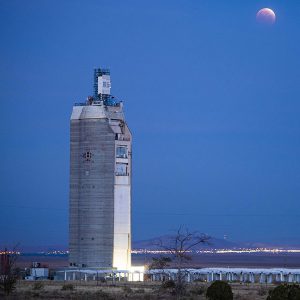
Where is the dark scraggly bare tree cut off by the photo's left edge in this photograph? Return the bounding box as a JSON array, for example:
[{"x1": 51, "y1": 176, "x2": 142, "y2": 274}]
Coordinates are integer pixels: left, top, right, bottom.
[{"x1": 0, "y1": 246, "x2": 18, "y2": 295}]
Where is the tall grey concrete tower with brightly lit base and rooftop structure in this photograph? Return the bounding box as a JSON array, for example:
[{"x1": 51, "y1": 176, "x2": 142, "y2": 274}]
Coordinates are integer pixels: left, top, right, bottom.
[{"x1": 69, "y1": 69, "x2": 132, "y2": 270}]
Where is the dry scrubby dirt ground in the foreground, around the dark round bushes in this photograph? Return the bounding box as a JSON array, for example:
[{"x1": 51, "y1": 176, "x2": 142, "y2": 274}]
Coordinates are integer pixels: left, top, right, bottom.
[{"x1": 0, "y1": 281, "x2": 275, "y2": 300}]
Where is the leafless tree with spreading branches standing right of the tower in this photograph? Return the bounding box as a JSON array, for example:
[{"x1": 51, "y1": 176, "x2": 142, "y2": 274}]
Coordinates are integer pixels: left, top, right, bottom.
[{"x1": 157, "y1": 225, "x2": 210, "y2": 295}]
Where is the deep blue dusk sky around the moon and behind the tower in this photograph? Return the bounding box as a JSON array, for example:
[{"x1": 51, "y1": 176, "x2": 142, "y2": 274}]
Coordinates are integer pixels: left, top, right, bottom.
[{"x1": 0, "y1": 0, "x2": 300, "y2": 247}]
